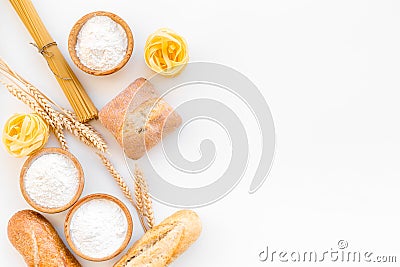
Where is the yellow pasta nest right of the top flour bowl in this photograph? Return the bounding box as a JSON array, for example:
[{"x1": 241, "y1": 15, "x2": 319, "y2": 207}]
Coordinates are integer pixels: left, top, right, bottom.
[{"x1": 144, "y1": 28, "x2": 189, "y2": 76}]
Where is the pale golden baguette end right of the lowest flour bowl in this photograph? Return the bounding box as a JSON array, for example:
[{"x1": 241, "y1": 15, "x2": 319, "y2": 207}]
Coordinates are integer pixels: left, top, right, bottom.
[{"x1": 114, "y1": 210, "x2": 201, "y2": 267}]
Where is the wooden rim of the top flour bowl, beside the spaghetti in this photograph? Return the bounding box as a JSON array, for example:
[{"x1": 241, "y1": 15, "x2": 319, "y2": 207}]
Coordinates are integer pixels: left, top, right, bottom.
[{"x1": 68, "y1": 11, "x2": 134, "y2": 76}]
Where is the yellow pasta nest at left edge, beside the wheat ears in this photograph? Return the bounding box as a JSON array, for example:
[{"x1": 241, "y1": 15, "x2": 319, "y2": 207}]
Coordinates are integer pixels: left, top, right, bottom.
[{"x1": 3, "y1": 114, "x2": 49, "y2": 158}]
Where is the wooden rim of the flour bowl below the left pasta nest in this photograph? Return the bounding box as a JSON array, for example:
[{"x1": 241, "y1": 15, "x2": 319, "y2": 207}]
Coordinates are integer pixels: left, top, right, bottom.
[{"x1": 19, "y1": 147, "x2": 85, "y2": 213}]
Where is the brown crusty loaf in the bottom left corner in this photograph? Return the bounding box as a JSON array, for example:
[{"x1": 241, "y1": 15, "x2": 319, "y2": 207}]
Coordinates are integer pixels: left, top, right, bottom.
[{"x1": 8, "y1": 210, "x2": 81, "y2": 267}]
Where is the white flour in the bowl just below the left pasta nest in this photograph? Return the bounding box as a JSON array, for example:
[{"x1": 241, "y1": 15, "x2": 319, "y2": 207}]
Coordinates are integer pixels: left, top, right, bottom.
[{"x1": 24, "y1": 153, "x2": 79, "y2": 208}]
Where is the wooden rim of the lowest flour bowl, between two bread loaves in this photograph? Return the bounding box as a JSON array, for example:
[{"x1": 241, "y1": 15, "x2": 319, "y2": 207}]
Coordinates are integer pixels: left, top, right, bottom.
[{"x1": 64, "y1": 194, "x2": 133, "y2": 262}]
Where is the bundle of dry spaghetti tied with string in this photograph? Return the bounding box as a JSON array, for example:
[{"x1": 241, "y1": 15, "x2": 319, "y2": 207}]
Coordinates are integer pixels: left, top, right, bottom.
[{"x1": 10, "y1": 0, "x2": 97, "y2": 122}]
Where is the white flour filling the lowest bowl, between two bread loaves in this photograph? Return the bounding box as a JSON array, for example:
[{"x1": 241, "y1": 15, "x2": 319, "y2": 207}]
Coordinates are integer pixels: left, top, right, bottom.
[{"x1": 69, "y1": 199, "x2": 128, "y2": 259}]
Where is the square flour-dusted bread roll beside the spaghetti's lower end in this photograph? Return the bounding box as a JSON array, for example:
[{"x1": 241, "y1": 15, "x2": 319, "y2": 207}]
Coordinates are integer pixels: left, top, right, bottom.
[{"x1": 99, "y1": 78, "x2": 182, "y2": 159}]
